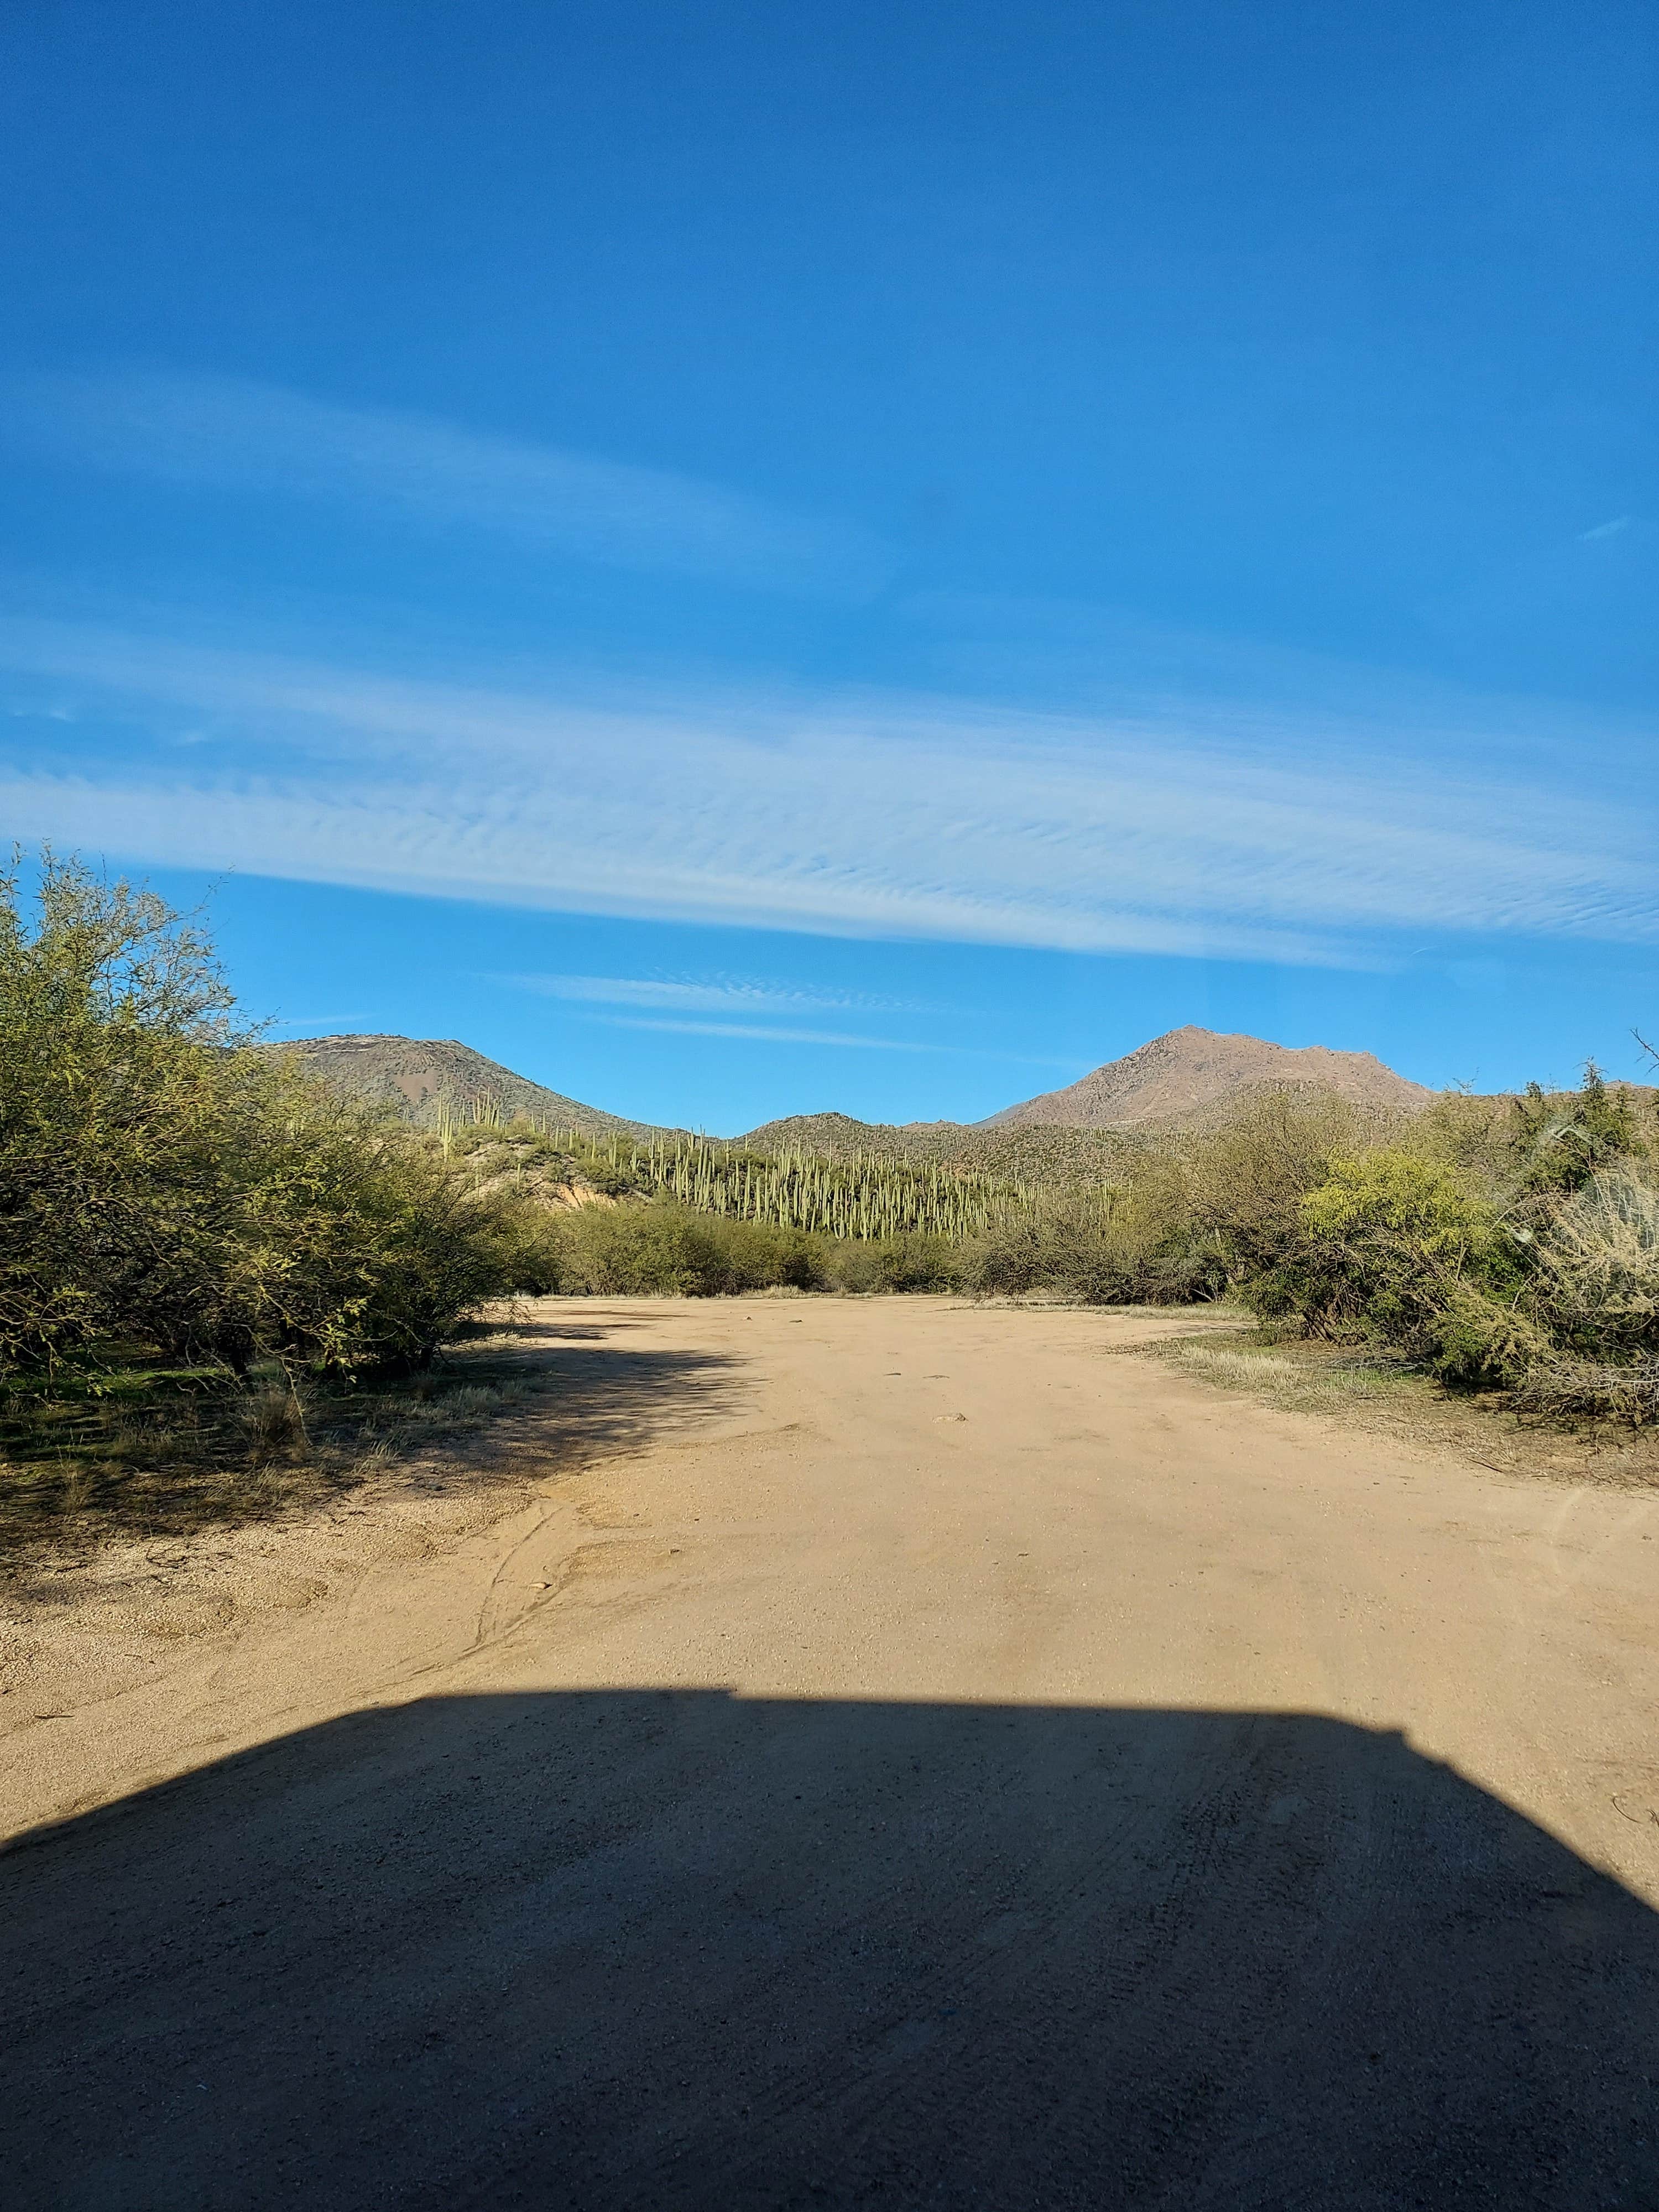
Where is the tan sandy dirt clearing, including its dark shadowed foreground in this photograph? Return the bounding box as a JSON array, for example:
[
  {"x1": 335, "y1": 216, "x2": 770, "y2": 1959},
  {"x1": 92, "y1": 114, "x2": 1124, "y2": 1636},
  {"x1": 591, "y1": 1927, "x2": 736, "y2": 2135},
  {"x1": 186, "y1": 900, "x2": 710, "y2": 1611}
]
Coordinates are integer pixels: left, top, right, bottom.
[{"x1": 0, "y1": 1298, "x2": 1659, "y2": 2212}]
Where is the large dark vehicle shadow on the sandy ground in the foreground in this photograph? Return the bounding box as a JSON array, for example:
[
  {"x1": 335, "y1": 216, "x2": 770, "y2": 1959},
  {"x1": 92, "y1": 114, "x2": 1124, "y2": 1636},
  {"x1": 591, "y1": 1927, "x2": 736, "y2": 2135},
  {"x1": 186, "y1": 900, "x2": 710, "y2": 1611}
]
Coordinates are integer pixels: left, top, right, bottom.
[{"x1": 0, "y1": 1690, "x2": 1659, "y2": 2212}]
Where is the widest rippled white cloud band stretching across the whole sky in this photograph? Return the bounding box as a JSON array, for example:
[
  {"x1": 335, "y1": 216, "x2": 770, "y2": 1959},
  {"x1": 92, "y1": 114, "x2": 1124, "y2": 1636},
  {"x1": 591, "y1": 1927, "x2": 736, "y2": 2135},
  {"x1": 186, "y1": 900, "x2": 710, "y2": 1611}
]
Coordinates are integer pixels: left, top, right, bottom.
[{"x1": 0, "y1": 622, "x2": 1659, "y2": 967}]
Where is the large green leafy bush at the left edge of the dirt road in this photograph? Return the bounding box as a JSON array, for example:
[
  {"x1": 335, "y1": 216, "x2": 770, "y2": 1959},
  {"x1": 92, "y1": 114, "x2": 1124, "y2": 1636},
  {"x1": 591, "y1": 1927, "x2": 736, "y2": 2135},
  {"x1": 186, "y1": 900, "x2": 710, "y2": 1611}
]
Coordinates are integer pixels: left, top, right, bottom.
[{"x1": 0, "y1": 854, "x2": 535, "y2": 1376}]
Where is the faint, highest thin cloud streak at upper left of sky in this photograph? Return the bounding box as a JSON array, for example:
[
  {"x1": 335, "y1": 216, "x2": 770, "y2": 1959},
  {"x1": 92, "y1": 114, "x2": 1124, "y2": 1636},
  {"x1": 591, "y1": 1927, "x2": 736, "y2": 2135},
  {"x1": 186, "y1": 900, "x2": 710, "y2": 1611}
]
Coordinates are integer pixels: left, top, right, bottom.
[{"x1": 4, "y1": 374, "x2": 891, "y2": 599}]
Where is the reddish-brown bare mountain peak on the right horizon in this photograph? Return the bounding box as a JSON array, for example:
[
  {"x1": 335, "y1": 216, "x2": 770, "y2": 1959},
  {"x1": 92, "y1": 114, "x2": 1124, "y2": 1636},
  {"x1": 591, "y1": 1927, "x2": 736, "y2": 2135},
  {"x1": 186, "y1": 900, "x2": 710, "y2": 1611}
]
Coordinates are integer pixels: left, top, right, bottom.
[{"x1": 978, "y1": 1024, "x2": 1431, "y2": 1130}]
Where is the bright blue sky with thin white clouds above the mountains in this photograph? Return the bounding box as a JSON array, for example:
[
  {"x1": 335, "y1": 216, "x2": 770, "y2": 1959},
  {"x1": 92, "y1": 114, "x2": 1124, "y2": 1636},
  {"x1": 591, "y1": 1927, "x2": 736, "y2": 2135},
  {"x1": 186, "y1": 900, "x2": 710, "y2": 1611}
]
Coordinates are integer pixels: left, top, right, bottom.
[{"x1": 0, "y1": 0, "x2": 1659, "y2": 1130}]
